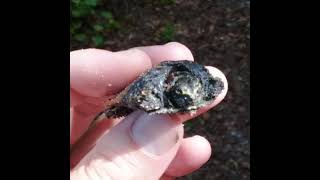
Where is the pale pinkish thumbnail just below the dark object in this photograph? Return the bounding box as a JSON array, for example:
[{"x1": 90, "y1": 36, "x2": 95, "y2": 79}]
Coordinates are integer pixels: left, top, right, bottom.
[{"x1": 131, "y1": 113, "x2": 181, "y2": 155}]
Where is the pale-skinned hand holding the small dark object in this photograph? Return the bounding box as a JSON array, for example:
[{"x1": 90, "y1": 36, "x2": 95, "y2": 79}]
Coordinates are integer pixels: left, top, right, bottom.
[{"x1": 70, "y1": 42, "x2": 228, "y2": 180}]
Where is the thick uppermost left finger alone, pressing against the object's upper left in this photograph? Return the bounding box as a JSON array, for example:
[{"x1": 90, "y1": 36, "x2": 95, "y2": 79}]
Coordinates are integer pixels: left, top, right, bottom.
[{"x1": 70, "y1": 49, "x2": 151, "y2": 103}]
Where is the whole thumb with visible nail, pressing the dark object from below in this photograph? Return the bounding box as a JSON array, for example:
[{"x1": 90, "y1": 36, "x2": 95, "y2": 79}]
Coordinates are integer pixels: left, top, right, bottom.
[{"x1": 70, "y1": 112, "x2": 183, "y2": 180}]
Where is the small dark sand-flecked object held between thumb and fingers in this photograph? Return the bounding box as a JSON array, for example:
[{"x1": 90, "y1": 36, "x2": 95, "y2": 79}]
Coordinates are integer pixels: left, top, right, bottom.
[{"x1": 93, "y1": 60, "x2": 224, "y2": 124}]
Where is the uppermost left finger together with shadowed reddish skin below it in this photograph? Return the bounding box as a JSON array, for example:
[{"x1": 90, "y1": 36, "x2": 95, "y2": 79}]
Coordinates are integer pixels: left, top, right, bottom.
[{"x1": 70, "y1": 49, "x2": 152, "y2": 144}]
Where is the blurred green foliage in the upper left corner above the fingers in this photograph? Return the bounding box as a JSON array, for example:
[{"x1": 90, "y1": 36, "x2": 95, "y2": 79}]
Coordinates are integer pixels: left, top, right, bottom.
[{"x1": 70, "y1": 0, "x2": 120, "y2": 47}]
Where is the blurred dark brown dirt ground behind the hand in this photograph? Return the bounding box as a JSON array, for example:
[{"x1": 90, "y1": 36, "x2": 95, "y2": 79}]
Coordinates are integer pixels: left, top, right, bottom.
[{"x1": 70, "y1": 0, "x2": 250, "y2": 180}]
